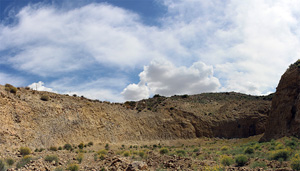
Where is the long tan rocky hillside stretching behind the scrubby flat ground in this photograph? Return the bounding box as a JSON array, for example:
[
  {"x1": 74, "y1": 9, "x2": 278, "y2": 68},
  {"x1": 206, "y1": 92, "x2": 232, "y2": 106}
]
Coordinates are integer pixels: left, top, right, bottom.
[{"x1": 0, "y1": 85, "x2": 272, "y2": 148}]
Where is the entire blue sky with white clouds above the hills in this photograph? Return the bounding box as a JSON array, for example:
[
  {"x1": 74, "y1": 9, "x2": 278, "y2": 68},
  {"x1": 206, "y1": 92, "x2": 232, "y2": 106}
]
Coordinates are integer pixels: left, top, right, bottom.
[{"x1": 0, "y1": 0, "x2": 300, "y2": 102}]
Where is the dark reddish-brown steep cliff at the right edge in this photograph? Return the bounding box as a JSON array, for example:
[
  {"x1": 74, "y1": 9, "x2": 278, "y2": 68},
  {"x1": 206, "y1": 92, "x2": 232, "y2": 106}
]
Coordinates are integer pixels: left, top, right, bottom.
[{"x1": 261, "y1": 61, "x2": 300, "y2": 141}]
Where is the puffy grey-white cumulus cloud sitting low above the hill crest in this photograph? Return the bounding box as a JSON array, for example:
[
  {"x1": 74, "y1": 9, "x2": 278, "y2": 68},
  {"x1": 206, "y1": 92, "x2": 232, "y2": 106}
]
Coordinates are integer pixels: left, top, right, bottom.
[{"x1": 122, "y1": 60, "x2": 220, "y2": 100}]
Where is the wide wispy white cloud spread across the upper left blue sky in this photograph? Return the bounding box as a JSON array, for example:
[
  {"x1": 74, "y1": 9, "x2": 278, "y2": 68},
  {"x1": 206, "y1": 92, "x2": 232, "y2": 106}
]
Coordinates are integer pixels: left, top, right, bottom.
[{"x1": 0, "y1": 4, "x2": 186, "y2": 76}]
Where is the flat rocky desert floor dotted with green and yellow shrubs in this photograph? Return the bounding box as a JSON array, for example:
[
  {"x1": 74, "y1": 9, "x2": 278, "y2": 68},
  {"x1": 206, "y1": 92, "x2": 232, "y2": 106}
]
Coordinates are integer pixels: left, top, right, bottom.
[{"x1": 0, "y1": 136, "x2": 300, "y2": 171}]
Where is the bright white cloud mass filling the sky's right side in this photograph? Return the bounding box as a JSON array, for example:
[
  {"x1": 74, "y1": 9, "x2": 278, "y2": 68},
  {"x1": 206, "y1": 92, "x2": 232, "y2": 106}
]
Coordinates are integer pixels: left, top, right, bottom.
[{"x1": 165, "y1": 0, "x2": 300, "y2": 94}]
